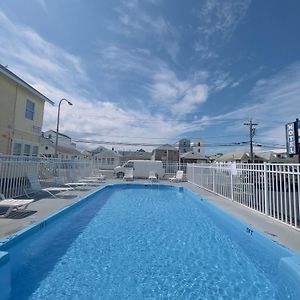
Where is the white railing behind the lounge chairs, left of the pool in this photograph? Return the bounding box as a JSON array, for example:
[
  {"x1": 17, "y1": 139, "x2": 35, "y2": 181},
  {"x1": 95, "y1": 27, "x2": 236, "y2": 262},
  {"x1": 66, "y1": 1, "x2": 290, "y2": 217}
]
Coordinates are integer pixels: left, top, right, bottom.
[{"x1": 0, "y1": 155, "x2": 97, "y2": 198}]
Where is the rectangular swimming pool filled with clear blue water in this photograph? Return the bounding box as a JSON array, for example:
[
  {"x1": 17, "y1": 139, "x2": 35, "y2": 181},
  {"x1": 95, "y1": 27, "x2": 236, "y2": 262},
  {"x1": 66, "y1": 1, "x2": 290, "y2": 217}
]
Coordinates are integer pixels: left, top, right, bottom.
[{"x1": 0, "y1": 184, "x2": 300, "y2": 300}]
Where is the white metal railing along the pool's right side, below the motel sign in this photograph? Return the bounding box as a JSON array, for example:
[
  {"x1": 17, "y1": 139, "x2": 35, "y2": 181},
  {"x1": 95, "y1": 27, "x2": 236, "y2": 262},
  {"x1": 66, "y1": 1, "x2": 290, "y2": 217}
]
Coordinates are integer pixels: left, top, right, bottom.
[{"x1": 187, "y1": 163, "x2": 300, "y2": 228}]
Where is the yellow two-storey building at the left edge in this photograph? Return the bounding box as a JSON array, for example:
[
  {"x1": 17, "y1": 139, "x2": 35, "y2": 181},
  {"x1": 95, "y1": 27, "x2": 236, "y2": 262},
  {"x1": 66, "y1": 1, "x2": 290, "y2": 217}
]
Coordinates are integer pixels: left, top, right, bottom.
[{"x1": 0, "y1": 64, "x2": 54, "y2": 156}]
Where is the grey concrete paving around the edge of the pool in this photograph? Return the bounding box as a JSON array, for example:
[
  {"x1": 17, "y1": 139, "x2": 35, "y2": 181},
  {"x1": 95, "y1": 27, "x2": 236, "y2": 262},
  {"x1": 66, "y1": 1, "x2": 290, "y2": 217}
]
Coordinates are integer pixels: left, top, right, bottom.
[{"x1": 0, "y1": 179, "x2": 300, "y2": 254}]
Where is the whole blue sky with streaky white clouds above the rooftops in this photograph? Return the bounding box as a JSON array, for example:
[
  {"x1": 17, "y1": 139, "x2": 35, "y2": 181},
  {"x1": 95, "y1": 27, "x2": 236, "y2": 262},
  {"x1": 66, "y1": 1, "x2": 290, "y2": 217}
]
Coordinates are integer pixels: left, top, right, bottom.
[{"x1": 0, "y1": 0, "x2": 300, "y2": 153}]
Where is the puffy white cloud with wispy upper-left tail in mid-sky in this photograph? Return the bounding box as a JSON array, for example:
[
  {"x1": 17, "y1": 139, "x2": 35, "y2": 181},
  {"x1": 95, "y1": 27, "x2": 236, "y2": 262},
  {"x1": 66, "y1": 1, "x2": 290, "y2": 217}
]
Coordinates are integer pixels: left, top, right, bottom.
[{"x1": 99, "y1": 45, "x2": 209, "y2": 116}]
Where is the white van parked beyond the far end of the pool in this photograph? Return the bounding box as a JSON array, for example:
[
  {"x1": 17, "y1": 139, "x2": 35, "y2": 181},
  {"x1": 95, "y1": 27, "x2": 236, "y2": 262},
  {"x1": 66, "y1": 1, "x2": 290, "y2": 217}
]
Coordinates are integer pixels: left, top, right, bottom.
[{"x1": 115, "y1": 160, "x2": 165, "y2": 178}]
